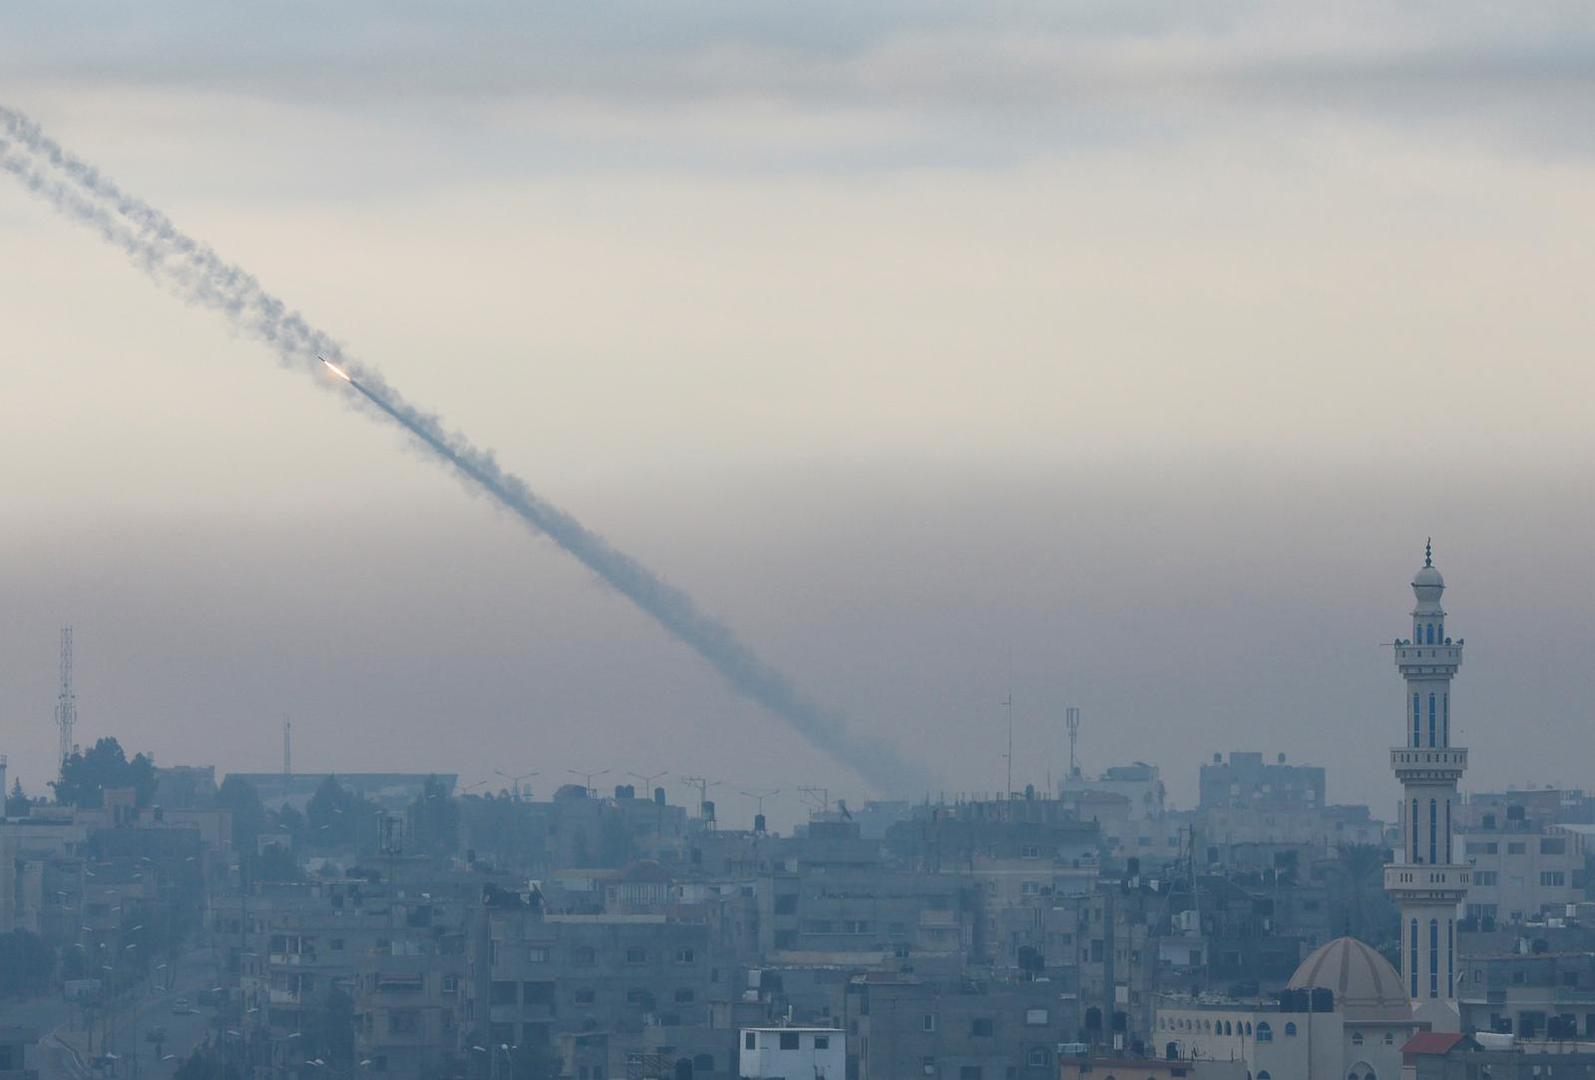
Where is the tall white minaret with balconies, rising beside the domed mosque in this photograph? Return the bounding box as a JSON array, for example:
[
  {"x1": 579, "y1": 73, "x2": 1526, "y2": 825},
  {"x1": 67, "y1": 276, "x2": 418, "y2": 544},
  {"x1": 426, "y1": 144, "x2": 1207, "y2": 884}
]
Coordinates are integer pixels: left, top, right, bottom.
[{"x1": 1384, "y1": 544, "x2": 1472, "y2": 1031}]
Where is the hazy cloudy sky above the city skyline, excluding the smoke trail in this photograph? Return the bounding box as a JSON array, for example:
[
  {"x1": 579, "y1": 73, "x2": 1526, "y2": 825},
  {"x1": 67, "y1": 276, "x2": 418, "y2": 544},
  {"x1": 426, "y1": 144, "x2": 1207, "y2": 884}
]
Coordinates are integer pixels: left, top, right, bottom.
[{"x1": 0, "y1": 0, "x2": 1595, "y2": 823}]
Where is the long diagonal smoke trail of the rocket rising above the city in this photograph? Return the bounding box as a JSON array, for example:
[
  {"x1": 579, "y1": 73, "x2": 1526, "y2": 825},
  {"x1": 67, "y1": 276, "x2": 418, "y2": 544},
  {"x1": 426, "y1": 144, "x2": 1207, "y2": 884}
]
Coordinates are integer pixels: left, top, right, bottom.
[{"x1": 0, "y1": 105, "x2": 928, "y2": 794}]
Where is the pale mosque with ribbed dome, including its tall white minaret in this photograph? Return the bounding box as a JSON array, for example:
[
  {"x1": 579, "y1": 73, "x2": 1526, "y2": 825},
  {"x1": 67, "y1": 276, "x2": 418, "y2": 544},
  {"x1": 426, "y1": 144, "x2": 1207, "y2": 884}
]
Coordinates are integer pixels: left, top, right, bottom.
[{"x1": 1155, "y1": 546, "x2": 1469, "y2": 1080}]
